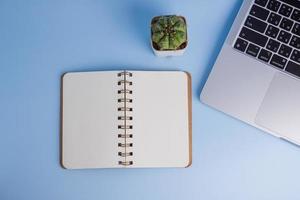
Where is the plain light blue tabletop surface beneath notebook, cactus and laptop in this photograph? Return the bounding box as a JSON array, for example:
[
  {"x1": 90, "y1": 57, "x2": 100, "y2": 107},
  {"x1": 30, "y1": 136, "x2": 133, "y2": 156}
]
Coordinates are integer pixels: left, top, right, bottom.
[{"x1": 0, "y1": 0, "x2": 300, "y2": 200}]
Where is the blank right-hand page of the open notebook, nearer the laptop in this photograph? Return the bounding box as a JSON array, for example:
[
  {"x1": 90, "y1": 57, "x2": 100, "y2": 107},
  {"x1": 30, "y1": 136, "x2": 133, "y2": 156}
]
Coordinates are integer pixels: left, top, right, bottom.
[{"x1": 127, "y1": 71, "x2": 191, "y2": 168}]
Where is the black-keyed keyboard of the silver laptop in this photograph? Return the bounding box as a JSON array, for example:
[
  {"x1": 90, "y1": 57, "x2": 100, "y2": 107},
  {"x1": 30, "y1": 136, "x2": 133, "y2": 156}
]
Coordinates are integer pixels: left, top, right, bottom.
[{"x1": 234, "y1": 0, "x2": 300, "y2": 78}]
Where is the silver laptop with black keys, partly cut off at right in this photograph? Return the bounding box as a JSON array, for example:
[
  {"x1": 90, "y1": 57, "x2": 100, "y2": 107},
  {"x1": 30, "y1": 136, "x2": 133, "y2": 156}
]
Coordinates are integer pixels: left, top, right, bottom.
[{"x1": 200, "y1": 0, "x2": 300, "y2": 145}]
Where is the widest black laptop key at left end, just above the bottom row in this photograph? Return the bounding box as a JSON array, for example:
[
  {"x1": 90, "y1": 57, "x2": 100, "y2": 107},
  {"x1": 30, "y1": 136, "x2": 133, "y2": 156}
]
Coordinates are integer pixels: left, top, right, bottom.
[{"x1": 240, "y1": 27, "x2": 268, "y2": 47}]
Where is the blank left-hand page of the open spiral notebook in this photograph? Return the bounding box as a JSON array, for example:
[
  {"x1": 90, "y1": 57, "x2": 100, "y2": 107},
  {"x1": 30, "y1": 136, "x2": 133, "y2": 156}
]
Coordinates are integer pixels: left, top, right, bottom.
[{"x1": 62, "y1": 71, "x2": 120, "y2": 169}]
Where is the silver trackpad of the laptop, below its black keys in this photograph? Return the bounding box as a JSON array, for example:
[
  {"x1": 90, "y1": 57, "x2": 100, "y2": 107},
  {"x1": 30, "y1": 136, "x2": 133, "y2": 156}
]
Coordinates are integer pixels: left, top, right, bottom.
[{"x1": 255, "y1": 72, "x2": 300, "y2": 144}]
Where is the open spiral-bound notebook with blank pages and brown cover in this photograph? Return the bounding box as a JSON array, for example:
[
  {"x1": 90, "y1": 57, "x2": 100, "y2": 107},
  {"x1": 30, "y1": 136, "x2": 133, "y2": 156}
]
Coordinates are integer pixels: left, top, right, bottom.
[{"x1": 62, "y1": 71, "x2": 192, "y2": 169}]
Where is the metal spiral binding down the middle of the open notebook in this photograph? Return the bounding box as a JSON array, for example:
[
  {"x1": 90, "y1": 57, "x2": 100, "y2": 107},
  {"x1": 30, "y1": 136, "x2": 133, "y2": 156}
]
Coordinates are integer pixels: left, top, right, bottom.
[{"x1": 118, "y1": 71, "x2": 133, "y2": 166}]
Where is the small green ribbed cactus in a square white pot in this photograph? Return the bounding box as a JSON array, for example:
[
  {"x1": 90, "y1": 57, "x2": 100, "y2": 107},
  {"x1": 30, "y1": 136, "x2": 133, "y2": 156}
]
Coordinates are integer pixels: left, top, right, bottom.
[{"x1": 151, "y1": 15, "x2": 188, "y2": 56}]
